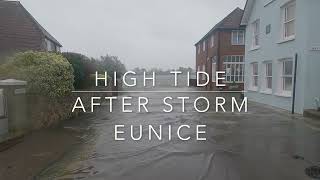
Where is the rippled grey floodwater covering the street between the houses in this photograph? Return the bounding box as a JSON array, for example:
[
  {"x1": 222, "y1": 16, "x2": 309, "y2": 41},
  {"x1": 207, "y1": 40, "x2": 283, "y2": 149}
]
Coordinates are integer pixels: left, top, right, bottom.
[{"x1": 38, "y1": 75, "x2": 320, "y2": 180}]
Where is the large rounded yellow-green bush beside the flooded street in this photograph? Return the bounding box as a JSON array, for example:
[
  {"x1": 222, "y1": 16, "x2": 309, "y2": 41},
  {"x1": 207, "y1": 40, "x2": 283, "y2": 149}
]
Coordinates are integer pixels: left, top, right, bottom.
[{"x1": 0, "y1": 51, "x2": 74, "y2": 98}]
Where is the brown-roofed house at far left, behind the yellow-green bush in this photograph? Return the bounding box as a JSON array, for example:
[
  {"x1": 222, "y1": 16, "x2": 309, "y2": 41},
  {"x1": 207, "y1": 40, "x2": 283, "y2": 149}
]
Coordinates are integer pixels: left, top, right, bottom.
[{"x1": 0, "y1": 1, "x2": 62, "y2": 59}]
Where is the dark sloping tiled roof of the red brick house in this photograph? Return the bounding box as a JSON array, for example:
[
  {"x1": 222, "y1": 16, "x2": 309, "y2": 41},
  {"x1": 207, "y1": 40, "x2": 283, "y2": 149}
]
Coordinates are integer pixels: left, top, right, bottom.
[{"x1": 195, "y1": 7, "x2": 243, "y2": 45}]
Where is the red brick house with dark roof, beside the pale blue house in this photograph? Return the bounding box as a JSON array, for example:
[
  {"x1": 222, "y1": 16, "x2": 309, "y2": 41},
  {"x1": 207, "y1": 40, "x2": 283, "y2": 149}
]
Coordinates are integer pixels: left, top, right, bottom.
[{"x1": 195, "y1": 8, "x2": 245, "y2": 90}]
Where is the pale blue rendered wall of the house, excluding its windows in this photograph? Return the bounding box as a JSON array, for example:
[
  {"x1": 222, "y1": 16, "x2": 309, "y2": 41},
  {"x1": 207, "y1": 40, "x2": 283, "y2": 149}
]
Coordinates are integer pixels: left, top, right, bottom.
[{"x1": 245, "y1": 0, "x2": 320, "y2": 113}]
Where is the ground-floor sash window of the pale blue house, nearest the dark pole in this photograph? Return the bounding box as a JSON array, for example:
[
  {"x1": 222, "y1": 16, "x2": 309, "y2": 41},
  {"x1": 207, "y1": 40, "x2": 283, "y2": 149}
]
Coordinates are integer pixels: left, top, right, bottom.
[{"x1": 281, "y1": 58, "x2": 293, "y2": 92}]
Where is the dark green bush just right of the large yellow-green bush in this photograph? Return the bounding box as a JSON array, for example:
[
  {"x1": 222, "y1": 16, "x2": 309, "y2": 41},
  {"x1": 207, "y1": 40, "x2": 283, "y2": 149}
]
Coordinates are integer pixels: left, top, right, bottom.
[{"x1": 62, "y1": 52, "x2": 97, "y2": 89}]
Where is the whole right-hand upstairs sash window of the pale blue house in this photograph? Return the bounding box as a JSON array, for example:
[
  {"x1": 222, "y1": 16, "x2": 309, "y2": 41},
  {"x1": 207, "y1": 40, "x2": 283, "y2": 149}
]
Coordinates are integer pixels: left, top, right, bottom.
[{"x1": 281, "y1": 1, "x2": 296, "y2": 39}]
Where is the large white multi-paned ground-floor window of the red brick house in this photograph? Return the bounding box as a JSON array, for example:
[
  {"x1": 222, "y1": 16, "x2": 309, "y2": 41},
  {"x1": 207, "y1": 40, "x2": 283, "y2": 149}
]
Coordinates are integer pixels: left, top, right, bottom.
[{"x1": 223, "y1": 56, "x2": 244, "y2": 83}]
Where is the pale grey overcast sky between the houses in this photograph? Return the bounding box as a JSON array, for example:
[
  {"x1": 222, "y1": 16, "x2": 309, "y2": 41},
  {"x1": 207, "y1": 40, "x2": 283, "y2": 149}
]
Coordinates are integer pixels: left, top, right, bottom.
[{"x1": 21, "y1": 0, "x2": 245, "y2": 69}]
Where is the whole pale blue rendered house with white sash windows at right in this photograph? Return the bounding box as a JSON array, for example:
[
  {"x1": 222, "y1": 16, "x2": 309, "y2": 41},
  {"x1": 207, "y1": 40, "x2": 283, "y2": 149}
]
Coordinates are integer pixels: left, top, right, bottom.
[{"x1": 241, "y1": 0, "x2": 320, "y2": 114}]
